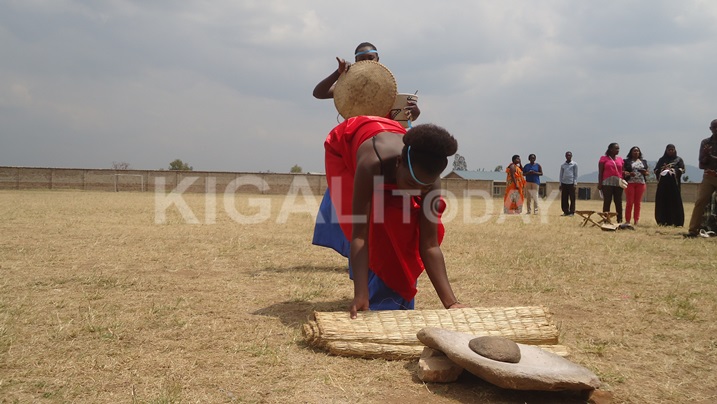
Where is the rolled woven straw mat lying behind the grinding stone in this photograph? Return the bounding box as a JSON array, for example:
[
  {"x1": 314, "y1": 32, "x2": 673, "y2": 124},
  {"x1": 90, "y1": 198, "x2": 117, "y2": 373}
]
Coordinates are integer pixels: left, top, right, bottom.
[{"x1": 303, "y1": 306, "x2": 568, "y2": 359}]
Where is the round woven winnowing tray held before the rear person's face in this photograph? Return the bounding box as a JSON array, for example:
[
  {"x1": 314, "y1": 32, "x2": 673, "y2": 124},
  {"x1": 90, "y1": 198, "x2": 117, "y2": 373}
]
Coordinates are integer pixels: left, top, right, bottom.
[{"x1": 334, "y1": 60, "x2": 398, "y2": 119}]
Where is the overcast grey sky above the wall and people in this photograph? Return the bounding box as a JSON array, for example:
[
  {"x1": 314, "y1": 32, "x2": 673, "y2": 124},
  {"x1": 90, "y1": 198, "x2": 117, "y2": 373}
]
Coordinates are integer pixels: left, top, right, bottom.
[{"x1": 0, "y1": 0, "x2": 717, "y2": 178}]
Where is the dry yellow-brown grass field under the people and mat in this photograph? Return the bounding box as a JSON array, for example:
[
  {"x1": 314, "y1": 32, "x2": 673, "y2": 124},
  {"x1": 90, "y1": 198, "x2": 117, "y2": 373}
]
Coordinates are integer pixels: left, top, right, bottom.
[{"x1": 0, "y1": 191, "x2": 717, "y2": 403}]
